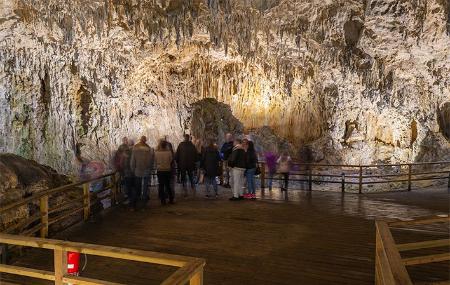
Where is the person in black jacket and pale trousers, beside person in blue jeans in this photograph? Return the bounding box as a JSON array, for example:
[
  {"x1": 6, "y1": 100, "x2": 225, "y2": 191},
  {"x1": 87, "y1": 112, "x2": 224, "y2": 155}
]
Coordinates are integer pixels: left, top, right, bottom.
[{"x1": 228, "y1": 139, "x2": 246, "y2": 201}]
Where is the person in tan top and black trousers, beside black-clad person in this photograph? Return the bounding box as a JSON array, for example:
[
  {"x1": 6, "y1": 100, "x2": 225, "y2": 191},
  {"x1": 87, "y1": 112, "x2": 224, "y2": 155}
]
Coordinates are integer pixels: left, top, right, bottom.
[{"x1": 155, "y1": 140, "x2": 175, "y2": 205}]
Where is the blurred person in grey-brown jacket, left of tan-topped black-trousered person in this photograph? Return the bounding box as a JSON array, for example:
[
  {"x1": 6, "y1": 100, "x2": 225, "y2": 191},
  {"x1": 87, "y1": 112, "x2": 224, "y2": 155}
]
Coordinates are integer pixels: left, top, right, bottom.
[{"x1": 130, "y1": 136, "x2": 155, "y2": 210}]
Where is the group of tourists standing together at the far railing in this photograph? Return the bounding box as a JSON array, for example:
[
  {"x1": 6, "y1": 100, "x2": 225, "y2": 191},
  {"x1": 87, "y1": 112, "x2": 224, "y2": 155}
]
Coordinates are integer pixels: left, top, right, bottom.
[{"x1": 114, "y1": 134, "x2": 291, "y2": 210}]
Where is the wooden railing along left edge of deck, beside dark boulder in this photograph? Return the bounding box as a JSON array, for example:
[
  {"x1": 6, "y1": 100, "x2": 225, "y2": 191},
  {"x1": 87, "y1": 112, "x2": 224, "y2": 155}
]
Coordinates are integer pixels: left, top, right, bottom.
[{"x1": 0, "y1": 173, "x2": 118, "y2": 238}]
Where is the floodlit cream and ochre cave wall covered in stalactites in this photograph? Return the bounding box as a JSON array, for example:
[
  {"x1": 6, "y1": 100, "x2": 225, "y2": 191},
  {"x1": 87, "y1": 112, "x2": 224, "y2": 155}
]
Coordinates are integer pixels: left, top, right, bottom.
[{"x1": 0, "y1": 0, "x2": 450, "y2": 172}]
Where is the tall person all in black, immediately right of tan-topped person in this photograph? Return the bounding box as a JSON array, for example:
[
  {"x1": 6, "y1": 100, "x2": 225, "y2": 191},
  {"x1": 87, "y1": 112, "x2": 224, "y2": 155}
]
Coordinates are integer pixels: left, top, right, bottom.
[{"x1": 175, "y1": 134, "x2": 198, "y2": 197}]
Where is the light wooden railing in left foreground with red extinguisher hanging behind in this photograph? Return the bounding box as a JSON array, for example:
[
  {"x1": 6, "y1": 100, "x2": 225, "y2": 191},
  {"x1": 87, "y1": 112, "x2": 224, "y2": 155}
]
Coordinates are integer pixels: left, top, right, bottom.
[{"x1": 0, "y1": 234, "x2": 205, "y2": 285}]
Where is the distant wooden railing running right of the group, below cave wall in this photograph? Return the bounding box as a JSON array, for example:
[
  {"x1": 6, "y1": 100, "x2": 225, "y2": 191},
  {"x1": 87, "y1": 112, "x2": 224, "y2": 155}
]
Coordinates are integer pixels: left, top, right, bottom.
[{"x1": 260, "y1": 161, "x2": 450, "y2": 194}]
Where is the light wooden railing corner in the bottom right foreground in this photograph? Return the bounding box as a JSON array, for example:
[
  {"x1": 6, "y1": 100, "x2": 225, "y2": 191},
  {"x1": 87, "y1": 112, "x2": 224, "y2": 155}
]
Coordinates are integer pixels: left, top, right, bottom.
[{"x1": 375, "y1": 216, "x2": 450, "y2": 285}]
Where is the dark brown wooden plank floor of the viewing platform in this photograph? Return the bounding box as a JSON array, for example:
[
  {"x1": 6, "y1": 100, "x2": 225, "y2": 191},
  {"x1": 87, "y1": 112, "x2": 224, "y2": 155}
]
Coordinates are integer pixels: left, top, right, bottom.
[{"x1": 4, "y1": 184, "x2": 450, "y2": 285}]
